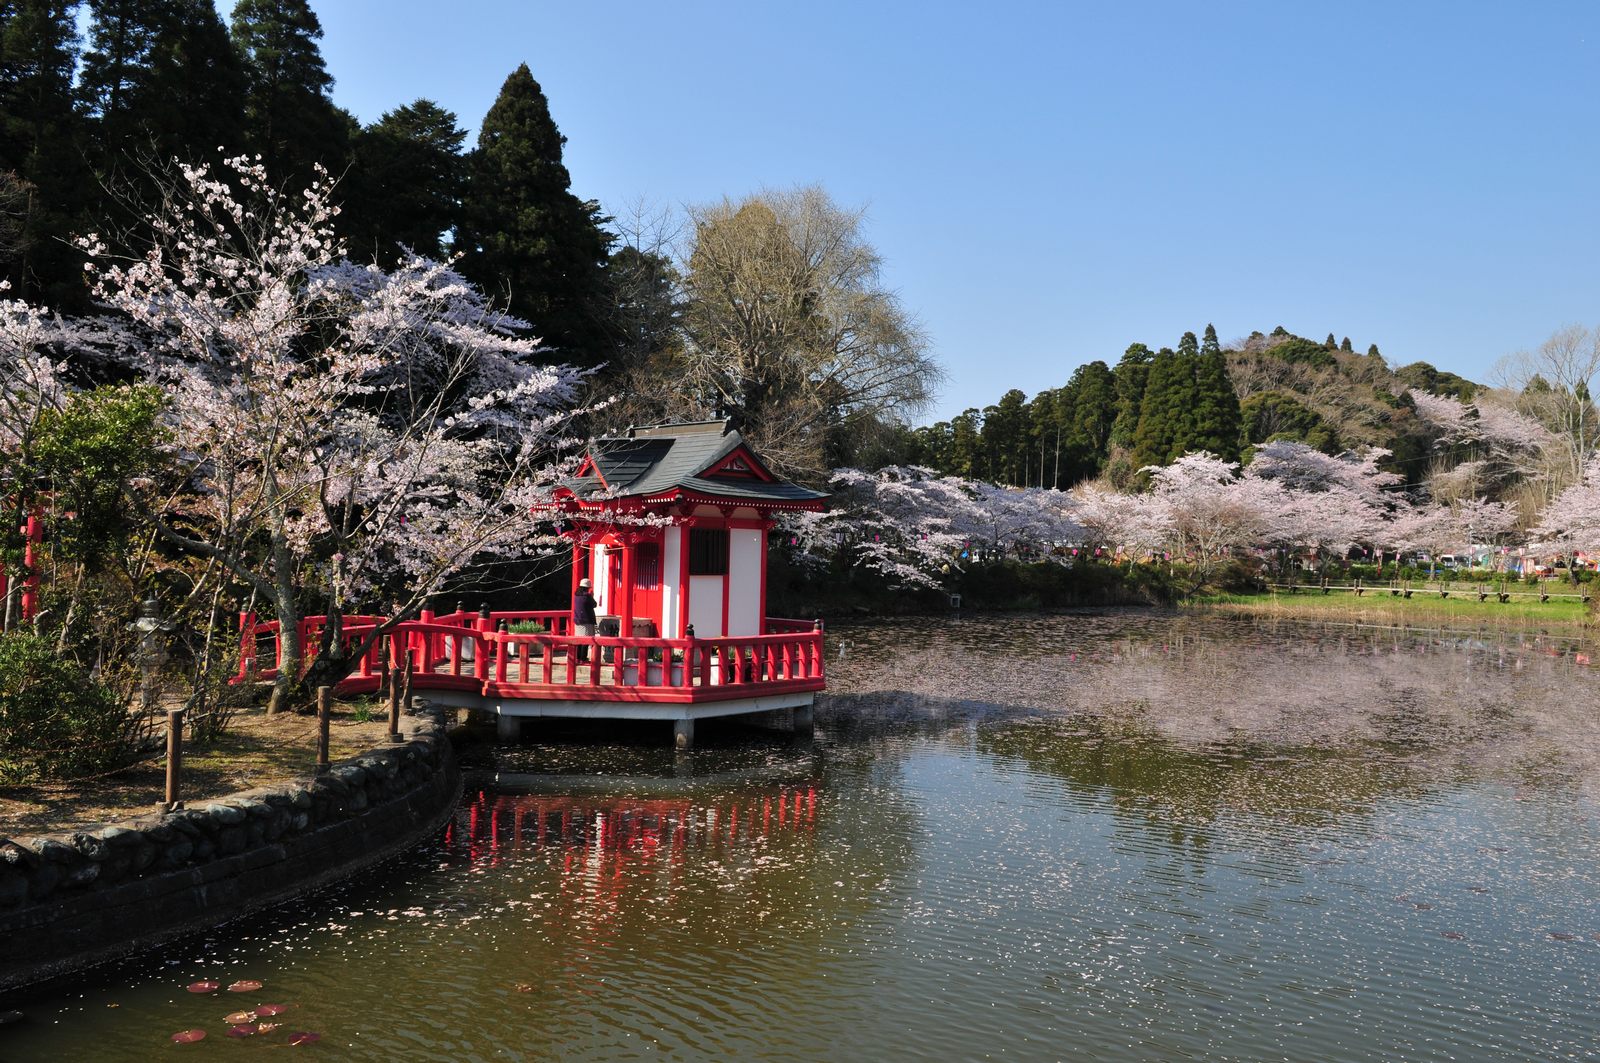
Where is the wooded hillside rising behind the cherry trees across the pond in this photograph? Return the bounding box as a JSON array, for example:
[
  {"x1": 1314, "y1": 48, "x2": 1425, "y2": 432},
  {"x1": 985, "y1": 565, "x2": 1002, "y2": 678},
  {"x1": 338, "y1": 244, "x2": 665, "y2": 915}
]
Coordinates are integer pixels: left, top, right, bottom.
[{"x1": 894, "y1": 325, "x2": 1480, "y2": 490}]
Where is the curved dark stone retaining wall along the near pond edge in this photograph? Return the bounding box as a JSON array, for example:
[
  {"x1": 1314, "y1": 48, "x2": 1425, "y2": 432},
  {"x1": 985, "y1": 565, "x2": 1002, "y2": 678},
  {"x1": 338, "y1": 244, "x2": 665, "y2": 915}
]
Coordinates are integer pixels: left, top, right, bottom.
[{"x1": 0, "y1": 706, "x2": 461, "y2": 994}]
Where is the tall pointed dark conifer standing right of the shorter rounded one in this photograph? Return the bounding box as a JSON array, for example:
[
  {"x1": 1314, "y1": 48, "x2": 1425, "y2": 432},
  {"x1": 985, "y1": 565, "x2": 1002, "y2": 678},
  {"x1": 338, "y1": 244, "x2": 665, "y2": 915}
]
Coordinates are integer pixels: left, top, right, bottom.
[{"x1": 461, "y1": 64, "x2": 611, "y2": 365}]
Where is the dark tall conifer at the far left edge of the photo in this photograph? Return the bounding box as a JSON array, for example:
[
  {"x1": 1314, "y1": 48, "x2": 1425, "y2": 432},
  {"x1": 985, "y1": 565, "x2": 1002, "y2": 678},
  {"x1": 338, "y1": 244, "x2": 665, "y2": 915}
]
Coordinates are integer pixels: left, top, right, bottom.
[{"x1": 0, "y1": 0, "x2": 93, "y2": 312}]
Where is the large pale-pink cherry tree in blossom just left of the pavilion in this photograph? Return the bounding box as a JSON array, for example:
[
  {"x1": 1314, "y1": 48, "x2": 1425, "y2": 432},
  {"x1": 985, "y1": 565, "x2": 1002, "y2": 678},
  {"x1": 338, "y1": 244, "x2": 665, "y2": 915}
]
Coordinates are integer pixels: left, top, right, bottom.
[{"x1": 73, "y1": 158, "x2": 581, "y2": 708}]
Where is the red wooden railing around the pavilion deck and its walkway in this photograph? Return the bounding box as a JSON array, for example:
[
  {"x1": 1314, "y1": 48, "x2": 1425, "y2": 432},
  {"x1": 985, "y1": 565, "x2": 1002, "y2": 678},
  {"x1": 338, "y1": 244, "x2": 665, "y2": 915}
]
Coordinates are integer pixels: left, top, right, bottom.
[{"x1": 234, "y1": 612, "x2": 826, "y2": 701}]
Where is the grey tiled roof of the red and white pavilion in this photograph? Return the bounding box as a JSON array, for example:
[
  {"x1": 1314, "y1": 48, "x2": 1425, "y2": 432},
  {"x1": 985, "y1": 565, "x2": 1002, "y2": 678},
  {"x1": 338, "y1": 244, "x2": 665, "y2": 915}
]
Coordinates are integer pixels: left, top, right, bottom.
[{"x1": 568, "y1": 421, "x2": 827, "y2": 503}]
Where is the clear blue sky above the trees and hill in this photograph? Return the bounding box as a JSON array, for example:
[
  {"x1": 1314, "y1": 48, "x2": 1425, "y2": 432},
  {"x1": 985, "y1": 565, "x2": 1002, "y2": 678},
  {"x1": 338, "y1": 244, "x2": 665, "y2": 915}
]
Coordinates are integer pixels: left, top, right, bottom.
[{"x1": 294, "y1": 0, "x2": 1600, "y2": 419}]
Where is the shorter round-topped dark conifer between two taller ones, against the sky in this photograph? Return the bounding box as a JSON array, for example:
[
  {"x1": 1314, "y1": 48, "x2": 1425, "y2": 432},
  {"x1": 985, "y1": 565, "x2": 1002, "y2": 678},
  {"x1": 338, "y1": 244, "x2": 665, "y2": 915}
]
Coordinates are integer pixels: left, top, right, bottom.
[{"x1": 344, "y1": 99, "x2": 467, "y2": 267}]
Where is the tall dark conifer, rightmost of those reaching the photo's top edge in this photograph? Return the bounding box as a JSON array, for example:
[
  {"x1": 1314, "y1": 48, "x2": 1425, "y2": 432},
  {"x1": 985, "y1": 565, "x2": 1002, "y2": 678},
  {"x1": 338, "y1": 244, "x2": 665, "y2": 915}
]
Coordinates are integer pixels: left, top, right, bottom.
[{"x1": 232, "y1": 0, "x2": 354, "y2": 184}]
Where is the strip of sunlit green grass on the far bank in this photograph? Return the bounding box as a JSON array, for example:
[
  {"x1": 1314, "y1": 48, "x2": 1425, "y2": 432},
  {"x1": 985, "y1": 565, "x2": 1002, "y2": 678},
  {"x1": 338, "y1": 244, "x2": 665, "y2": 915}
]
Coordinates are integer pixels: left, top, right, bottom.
[{"x1": 1189, "y1": 586, "x2": 1594, "y2": 634}]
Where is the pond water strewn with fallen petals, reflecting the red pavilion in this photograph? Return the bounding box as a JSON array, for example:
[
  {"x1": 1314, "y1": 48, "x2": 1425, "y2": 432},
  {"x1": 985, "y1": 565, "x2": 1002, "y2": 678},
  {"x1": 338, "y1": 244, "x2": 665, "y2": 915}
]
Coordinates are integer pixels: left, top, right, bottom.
[{"x1": 0, "y1": 613, "x2": 1600, "y2": 1061}]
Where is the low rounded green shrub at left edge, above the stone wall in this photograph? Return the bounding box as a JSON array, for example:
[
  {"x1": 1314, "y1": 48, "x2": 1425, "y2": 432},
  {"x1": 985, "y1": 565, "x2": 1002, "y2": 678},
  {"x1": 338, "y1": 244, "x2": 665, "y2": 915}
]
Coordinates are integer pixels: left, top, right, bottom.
[{"x1": 0, "y1": 631, "x2": 134, "y2": 784}]
